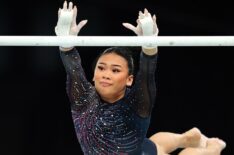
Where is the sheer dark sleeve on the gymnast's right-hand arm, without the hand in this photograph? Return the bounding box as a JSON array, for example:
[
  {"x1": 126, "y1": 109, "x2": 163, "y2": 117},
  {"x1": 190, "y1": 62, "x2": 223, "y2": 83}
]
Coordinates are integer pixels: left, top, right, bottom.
[{"x1": 130, "y1": 52, "x2": 157, "y2": 117}]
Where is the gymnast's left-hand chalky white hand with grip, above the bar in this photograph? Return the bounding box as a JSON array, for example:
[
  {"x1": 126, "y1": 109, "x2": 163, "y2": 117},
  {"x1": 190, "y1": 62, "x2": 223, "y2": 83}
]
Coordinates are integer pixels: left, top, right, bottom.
[{"x1": 55, "y1": 1, "x2": 87, "y2": 36}]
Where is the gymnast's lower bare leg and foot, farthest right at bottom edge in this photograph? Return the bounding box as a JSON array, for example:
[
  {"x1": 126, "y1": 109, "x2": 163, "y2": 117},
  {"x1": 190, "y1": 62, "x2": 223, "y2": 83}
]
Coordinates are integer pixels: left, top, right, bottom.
[{"x1": 179, "y1": 138, "x2": 226, "y2": 155}]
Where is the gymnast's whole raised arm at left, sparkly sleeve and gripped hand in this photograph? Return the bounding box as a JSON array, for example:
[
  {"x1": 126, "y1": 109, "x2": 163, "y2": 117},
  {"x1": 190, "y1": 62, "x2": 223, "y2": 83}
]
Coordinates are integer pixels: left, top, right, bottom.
[{"x1": 55, "y1": 1, "x2": 94, "y2": 110}]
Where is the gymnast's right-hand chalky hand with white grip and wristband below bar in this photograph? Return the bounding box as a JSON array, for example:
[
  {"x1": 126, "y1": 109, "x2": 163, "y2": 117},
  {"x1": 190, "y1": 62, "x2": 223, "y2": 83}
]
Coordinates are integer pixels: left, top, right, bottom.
[{"x1": 123, "y1": 9, "x2": 159, "y2": 55}]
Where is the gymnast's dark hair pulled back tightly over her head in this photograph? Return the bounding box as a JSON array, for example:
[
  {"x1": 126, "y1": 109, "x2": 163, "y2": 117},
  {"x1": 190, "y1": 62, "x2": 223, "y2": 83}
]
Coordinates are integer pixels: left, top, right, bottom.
[{"x1": 93, "y1": 47, "x2": 134, "y2": 75}]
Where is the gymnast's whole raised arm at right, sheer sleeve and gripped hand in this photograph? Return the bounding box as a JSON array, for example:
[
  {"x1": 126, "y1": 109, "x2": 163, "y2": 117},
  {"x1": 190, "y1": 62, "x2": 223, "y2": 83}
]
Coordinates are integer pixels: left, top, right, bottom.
[{"x1": 123, "y1": 9, "x2": 158, "y2": 117}]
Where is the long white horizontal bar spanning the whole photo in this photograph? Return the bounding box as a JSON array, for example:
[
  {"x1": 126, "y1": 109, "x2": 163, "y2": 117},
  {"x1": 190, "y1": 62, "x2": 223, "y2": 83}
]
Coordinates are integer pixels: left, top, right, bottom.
[{"x1": 0, "y1": 36, "x2": 234, "y2": 47}]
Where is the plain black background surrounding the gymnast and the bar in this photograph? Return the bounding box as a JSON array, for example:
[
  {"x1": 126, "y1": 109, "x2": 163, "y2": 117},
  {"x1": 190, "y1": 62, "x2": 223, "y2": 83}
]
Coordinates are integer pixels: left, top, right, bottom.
[{"x1": 0, "y1": 0, "x2": 234, "y2": 155}]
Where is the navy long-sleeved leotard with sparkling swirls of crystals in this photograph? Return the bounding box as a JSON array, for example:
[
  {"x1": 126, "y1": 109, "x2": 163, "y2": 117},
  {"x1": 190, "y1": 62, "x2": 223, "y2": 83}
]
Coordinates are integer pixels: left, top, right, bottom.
[{"x1": 60, "y1": 49, "x2": 157, "y2": 155}]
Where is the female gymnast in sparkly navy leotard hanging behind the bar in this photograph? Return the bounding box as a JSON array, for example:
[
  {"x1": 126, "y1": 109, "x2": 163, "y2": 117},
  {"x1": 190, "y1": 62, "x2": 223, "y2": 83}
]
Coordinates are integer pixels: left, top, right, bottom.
[{"x1": 55, "y1": 1, "x2": 226, "y2": 155}]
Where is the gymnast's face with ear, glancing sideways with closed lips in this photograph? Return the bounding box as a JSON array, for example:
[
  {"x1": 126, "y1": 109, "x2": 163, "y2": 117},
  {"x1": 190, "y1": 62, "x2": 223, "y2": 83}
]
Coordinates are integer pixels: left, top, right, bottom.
[{"x1": 93, "y1": 53, "x2": 133, "y2": 103}]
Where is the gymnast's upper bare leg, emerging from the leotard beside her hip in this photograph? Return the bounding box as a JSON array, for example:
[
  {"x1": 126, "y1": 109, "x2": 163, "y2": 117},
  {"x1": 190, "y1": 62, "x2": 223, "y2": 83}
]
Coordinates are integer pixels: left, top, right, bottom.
[{"x1": 150, "y1": 128, "x2": 204, "y2": 154}]
